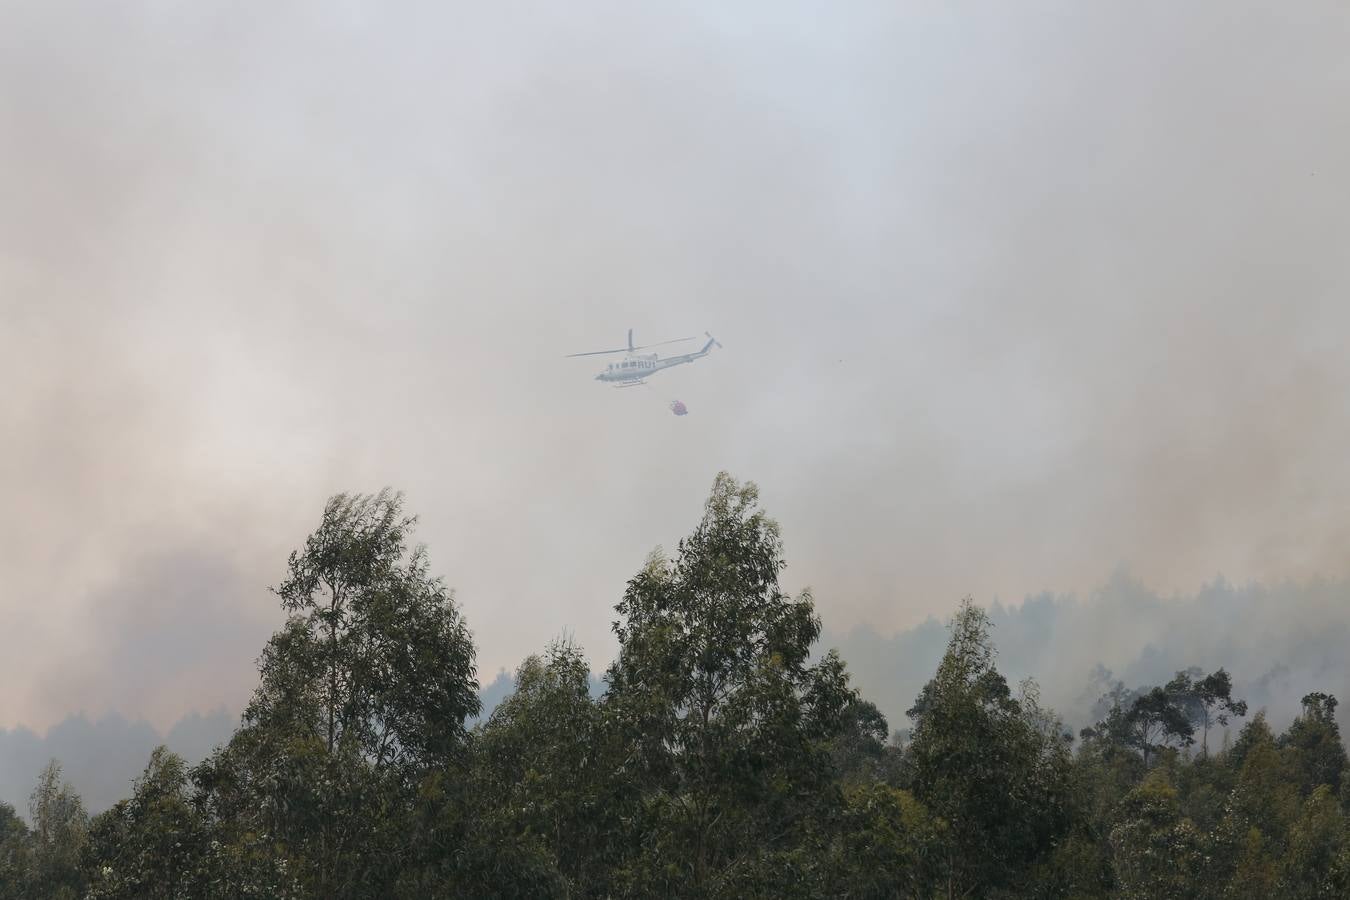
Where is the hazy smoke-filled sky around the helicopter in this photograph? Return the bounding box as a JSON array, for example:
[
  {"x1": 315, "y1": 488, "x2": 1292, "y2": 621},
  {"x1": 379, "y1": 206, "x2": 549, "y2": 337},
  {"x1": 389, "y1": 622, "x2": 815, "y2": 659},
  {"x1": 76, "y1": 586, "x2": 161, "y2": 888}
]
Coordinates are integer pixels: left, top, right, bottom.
[{"x1": 0, "y1": 0, "x2": 1350, "y2": 729}]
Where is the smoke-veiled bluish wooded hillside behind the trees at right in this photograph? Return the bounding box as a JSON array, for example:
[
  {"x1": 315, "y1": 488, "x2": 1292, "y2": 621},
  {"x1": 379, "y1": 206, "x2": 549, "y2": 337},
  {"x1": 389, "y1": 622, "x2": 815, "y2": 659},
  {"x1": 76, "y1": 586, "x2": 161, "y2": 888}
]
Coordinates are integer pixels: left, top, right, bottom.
[{"x1": 822, "y1": 572, "x2": 1350, "y2": 731}]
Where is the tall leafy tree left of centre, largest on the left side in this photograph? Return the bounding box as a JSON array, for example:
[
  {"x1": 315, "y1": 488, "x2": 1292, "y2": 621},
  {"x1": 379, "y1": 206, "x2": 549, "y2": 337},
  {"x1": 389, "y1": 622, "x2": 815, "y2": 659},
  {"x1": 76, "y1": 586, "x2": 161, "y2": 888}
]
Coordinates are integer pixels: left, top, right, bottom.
[{"x1": 198, "y1": 491, "x2": 479, "y2": 897}]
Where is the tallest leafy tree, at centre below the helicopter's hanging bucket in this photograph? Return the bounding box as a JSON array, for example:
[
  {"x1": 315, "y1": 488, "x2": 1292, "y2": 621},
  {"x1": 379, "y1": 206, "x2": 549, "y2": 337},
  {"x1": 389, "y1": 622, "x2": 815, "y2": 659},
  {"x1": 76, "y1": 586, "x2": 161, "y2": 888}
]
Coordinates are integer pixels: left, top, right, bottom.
[{"x1": 605, "y1": 472, "x2": 853, "y2": 897}]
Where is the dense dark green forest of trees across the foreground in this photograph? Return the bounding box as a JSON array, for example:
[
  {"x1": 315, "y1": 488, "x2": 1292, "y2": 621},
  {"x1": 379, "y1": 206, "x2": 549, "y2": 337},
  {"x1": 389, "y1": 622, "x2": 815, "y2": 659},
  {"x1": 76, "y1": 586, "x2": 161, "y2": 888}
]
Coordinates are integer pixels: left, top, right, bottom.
[{"x1": 0, "y1": 474, "x2": 1350, "y2": 900}]
